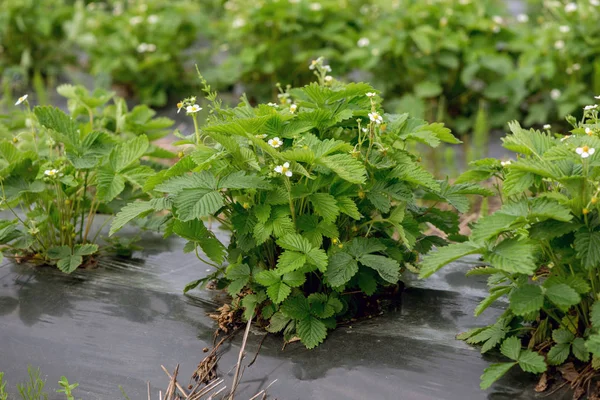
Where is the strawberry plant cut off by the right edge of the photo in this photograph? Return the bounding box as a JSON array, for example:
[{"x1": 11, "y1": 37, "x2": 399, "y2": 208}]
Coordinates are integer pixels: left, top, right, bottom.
[{"x1": 420, "y1": 104, "x2": 600, "y2": 388}]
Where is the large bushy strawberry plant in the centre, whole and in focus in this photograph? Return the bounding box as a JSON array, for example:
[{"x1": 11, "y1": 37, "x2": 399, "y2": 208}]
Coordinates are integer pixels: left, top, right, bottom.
[{"x1": 111, "y1": 59, "x2": 488, "y2": 348}]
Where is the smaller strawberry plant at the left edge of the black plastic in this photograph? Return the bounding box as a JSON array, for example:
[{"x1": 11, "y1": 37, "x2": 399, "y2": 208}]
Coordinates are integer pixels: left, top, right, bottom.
[{"x1": 0, "y1": 85, "x2": 174, "y2": 273}]
